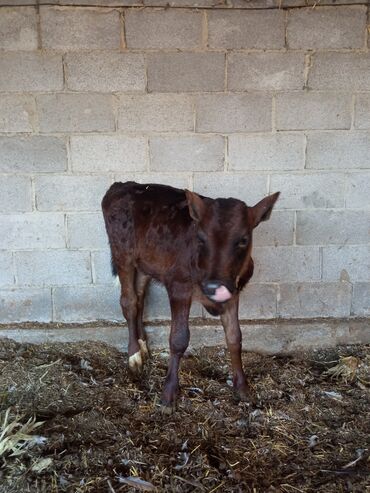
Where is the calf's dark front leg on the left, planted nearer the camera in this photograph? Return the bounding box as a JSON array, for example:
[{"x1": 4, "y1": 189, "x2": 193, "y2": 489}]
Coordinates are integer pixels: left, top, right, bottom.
[{"x1": 161, "y1": 290, "x2": 191, "y2": 412}]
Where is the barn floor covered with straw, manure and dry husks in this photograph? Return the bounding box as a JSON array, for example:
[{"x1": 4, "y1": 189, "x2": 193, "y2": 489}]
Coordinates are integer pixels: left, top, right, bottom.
[{"x1": 0, "y1": 339, "x2": 370, "y2": 493}]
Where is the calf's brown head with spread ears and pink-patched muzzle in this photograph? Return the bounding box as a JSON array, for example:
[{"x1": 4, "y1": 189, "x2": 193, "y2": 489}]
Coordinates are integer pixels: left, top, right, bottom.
[{"x1": 186, "y1": 190, "x2": 279, "y2": 303}]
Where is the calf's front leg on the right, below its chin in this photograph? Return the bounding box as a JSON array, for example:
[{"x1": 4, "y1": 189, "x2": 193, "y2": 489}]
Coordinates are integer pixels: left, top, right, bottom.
[{"x1": 221, "y1": 296, "x2": 251, "y2": 401}]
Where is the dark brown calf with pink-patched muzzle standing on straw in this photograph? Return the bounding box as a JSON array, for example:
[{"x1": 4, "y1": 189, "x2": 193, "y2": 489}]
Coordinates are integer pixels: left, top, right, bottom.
[{"x1": 102, "y1": 182, "x2": 279, "y2": 408}]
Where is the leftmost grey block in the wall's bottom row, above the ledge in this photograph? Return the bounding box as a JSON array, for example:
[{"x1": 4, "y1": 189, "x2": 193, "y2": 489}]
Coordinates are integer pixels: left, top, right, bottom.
[{"x1": 0, "y1": 288, "x2": 52, "y2": 324}]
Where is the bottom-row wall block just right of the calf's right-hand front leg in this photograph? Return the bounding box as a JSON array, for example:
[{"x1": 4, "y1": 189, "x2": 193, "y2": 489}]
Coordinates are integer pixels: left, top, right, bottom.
[{"x1": 239, "y1": 284, "x2": 277, "y2": 320}]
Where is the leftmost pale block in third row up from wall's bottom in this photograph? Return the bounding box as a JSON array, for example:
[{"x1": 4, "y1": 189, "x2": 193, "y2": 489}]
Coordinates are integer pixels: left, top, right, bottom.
[{"x1": 0, "y1": 213, "x2": 65, "y2": 250}]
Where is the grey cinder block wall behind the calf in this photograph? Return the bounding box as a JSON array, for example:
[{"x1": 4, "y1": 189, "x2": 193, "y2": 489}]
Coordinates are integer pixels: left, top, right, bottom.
[{"x1": 0, "y1": 0, "x2": 370, "y2": 323}]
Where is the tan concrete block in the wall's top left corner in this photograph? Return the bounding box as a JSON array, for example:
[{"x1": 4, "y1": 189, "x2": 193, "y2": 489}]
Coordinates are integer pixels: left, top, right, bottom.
[{"x1": 0, "y1": 6, "x2": 38, "y2": 51}]
